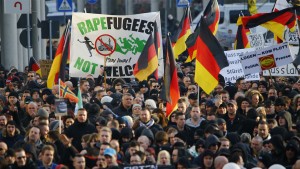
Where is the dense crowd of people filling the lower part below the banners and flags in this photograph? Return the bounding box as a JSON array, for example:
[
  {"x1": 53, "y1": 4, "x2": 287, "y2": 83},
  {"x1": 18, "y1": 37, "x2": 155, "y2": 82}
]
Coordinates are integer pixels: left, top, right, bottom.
[{"x1": 0, "y1": 59, "x2": 300, "y2": 169}]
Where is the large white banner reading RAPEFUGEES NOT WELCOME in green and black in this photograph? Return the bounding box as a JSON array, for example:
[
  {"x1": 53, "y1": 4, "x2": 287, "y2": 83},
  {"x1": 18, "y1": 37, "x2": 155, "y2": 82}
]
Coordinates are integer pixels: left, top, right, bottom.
[{"x1": 70, "y1": 12, "x2": 163, "y2": 78}]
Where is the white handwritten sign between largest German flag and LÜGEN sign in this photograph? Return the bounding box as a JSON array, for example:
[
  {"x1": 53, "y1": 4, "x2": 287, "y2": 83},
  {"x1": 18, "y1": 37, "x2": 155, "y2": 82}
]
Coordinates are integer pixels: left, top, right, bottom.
[{"x1": 220, "y1": 48, "x2": 259, "y2": 83}]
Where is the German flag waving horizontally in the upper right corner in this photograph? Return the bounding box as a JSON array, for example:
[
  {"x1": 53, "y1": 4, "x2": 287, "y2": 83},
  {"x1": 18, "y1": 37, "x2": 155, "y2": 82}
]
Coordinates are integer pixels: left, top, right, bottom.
[{"x1": 242, "y1": 8, "x2": 296, "y2": 40}]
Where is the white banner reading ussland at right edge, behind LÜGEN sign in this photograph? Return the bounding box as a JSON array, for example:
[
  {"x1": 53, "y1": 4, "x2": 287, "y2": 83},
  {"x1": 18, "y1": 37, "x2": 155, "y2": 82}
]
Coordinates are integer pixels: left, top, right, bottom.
[{"x1": 263, "y1": 46, "x2": 300, "y2": 76}]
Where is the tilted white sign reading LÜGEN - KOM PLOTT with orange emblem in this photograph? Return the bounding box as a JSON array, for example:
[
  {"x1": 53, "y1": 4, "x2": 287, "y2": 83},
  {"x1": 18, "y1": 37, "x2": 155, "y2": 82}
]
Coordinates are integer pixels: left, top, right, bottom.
[{"x1": 241, "y1": 42, "x2": 293, "y2": 74}]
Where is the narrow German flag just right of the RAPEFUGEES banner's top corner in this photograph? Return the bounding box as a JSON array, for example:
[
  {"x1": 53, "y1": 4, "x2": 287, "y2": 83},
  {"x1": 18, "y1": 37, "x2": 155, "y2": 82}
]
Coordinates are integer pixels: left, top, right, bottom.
[{"x1": 173, "y1": 7, "x2": 191, "y2": 59}]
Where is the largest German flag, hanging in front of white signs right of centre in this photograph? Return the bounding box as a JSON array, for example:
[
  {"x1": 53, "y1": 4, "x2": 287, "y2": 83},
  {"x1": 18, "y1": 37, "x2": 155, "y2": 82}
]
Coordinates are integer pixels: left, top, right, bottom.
[{"x1": 195, "y1": 17, "x2": 229, "y2": 94}]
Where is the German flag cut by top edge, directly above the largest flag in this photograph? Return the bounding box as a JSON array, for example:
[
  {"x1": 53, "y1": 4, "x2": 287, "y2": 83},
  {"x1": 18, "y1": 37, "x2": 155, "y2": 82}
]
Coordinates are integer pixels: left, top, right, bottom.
[{"x1": 203, "y1": 0, "x2": 220, "y2": 35}]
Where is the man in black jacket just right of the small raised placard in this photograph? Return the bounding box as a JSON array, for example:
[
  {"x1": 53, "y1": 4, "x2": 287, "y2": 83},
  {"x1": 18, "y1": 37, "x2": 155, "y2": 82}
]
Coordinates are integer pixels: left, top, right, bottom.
[{"x1": 65, "y1": 108, "x2": 97, "y2": 151}]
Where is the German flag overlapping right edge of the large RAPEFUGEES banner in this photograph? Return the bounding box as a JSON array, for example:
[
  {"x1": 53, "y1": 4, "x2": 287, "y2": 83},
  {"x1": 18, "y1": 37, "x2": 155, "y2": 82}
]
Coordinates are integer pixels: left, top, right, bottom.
[{"x1": 133, "y1": 34, "x2": 158, "y2": 81}]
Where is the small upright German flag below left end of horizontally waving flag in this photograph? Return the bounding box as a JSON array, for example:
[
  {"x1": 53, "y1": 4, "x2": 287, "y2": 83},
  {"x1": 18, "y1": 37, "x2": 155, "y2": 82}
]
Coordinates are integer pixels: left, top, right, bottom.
[{"x1": 234, "y1": 18, "x2": 250, "y2": 49}]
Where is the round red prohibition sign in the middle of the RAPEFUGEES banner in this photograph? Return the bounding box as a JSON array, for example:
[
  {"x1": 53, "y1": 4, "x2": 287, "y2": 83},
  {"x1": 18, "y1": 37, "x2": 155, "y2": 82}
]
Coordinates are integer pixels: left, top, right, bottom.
[{"x1": 95, "y1": 34, "x2": 117, "y2": 56}]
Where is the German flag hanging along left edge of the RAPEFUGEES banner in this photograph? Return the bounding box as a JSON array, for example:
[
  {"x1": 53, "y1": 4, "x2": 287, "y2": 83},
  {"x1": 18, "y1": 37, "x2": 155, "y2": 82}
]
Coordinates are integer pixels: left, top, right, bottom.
[{"x1": 47, "y1": 26, "x2": 70, "y2": 89}]
